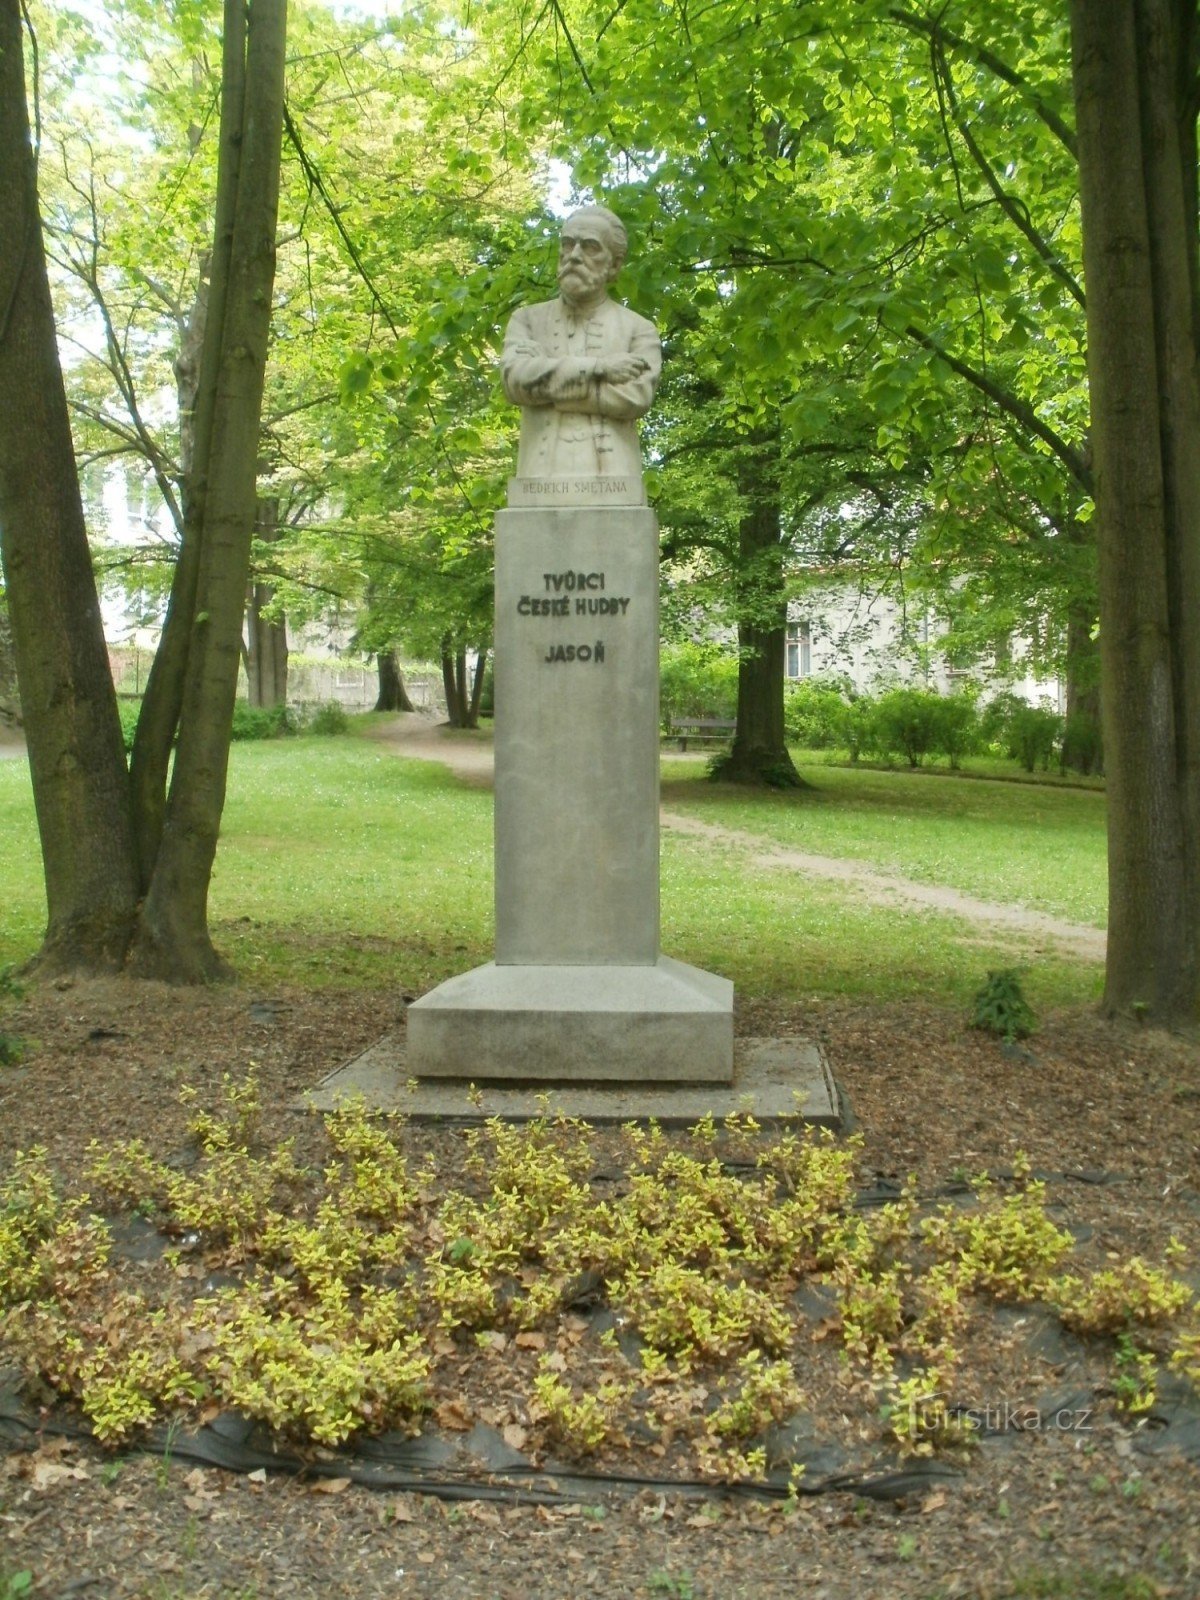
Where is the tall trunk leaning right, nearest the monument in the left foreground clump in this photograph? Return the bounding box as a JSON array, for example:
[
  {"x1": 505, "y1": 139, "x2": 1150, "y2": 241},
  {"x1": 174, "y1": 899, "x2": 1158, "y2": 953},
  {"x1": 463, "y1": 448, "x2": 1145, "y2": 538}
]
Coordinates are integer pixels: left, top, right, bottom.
[{"x1": 134, "y1": 0, "x2": 286, "y2": 981}]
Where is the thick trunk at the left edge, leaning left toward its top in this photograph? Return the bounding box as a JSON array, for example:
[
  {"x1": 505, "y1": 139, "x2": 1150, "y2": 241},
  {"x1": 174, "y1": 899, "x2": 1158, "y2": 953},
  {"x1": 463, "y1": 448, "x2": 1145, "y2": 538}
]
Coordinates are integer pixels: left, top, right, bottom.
[{"x1": 0, "y1": 0, "x2": 138, "y2": 970}]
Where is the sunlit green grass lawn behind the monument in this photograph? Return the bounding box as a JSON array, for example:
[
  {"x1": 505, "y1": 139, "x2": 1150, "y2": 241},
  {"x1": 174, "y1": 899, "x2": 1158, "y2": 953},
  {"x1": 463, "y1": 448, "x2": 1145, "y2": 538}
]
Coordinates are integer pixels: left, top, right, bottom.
[{"x1": 0, "y1": 738, "x2": 1104, "y2": 1006}]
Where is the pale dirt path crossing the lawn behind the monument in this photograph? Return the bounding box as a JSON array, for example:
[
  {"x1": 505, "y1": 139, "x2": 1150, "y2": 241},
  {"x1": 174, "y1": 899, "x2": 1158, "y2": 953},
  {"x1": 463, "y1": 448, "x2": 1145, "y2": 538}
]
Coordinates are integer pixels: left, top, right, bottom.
[{"x1": 371, "y1": 712, "x2": 1106, "y2": 962}]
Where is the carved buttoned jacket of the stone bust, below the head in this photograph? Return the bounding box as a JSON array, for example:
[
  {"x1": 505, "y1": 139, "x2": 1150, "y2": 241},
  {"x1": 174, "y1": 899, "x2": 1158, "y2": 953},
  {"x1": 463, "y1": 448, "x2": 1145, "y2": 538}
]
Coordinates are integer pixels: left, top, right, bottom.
[{"x1": 501, "y1": 299, "x2": 662, "y2": 483}]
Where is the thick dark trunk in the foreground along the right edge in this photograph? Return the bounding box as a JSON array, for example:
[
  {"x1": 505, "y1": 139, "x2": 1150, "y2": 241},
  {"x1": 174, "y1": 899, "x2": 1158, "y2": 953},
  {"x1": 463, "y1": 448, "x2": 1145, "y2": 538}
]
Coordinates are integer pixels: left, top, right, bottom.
[{"x1": 1070, "y1": 0, "x2": 1200, "y2": 1024}]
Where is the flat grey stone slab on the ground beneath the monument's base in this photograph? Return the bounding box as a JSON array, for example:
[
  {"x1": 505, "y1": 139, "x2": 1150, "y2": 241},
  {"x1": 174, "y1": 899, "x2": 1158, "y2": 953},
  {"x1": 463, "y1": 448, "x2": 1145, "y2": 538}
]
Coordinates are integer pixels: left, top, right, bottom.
[{"x1": 296, "y1": 1034, "x2": 850, "y2": 1130}]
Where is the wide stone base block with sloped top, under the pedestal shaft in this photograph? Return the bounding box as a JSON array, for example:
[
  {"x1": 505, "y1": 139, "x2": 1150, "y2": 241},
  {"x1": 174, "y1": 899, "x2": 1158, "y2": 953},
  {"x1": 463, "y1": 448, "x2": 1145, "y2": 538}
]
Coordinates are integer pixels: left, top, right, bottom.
[{"x1": 406, "y1": 955, "x2": 733, "y2": 1085}]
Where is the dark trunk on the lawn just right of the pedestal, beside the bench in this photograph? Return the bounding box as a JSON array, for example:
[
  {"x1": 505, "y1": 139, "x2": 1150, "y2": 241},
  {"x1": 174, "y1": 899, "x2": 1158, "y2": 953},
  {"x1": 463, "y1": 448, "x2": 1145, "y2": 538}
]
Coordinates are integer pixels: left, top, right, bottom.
[{"x1": 712, "y1": 451, "x2": 805, "y2": 789}]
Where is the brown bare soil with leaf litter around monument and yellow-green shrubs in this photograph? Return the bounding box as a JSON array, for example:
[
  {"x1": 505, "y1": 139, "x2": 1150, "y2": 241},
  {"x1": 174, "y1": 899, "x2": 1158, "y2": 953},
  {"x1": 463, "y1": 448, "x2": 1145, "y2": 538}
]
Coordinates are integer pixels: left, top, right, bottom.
[{"x1": 0, "y1": 730, "x2": 1200, "y2": 1600}]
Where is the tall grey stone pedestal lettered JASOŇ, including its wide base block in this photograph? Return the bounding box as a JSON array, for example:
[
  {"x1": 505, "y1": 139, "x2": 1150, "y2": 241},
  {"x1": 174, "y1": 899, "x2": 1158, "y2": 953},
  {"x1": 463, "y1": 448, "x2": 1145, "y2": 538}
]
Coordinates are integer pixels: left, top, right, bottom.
[{"x1": 408, "y1": 504, "x2": 733, "y2": 1083}]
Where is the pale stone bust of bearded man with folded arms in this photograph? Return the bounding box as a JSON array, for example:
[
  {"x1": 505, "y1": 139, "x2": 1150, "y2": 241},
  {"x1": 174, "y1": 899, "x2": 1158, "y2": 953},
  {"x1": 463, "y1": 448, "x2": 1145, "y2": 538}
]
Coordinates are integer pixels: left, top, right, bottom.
[{"x1": 501, "y1": 205, "x2": 662, "y2": 506}]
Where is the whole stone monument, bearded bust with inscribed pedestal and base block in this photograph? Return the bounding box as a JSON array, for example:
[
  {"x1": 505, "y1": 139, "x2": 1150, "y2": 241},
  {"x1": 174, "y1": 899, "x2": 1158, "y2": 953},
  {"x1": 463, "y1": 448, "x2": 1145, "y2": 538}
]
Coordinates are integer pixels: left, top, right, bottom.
[{"x1": 408, "y1": 206, "x2": 733, "y2": 1083}]
